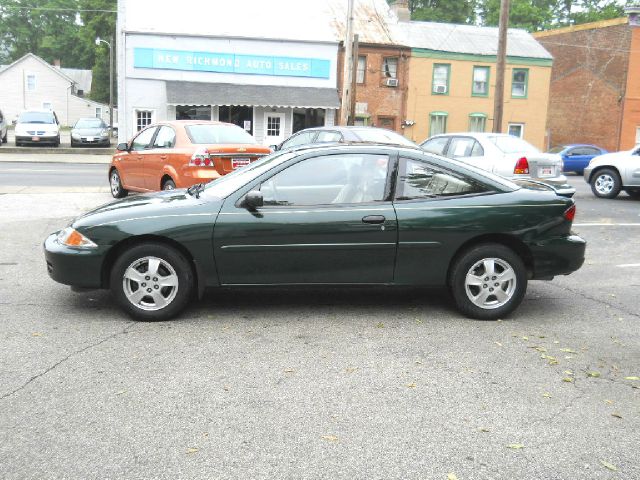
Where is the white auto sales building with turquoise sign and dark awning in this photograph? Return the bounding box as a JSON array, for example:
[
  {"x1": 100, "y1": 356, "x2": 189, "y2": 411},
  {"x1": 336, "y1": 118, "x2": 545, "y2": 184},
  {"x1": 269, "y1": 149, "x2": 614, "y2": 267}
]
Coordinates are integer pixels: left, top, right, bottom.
[{"x1": 117, "y1": 0, "x2": 340, "y2": 145}]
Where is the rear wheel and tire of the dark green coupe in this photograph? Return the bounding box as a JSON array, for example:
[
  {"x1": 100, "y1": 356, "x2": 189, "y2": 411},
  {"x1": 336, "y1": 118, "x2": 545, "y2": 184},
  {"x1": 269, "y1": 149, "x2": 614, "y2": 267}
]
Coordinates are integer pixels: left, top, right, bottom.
[{"x1": 449, "y1": 243, "x2": 527, "y2": 320}]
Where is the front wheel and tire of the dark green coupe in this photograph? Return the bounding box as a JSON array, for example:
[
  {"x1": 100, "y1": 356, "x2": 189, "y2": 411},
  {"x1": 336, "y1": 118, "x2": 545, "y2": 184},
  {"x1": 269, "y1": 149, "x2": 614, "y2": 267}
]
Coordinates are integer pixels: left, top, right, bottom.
[{"x1": 110, "y1": 243, "x2": 195, "y2": 322}]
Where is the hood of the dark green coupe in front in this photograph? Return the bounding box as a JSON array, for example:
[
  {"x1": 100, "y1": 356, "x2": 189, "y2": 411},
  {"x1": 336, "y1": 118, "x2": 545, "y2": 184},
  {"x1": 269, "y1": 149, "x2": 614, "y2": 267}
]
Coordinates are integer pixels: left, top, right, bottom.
[{"x1": 72, "y1": 189, "x2": 222, "y2": 230}]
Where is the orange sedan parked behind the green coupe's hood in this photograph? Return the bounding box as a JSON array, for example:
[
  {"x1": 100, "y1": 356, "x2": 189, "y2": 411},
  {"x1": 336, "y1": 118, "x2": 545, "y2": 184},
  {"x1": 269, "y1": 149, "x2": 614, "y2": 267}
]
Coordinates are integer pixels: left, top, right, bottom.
[{"x1": 109, "y1": 120, "x2": 271, "y2": 198}]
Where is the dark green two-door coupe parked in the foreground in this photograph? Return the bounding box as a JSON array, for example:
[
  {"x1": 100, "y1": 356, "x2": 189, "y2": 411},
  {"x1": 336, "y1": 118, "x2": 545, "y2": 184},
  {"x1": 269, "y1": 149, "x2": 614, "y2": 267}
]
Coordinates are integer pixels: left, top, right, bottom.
[{"x1": 45, "y1": 145, "x2": 586, "y2": 320}]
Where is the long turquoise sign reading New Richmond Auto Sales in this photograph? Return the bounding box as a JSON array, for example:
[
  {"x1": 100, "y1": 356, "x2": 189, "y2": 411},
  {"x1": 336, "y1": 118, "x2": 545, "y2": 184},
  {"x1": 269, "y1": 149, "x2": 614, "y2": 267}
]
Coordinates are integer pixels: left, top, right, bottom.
[{"x1": 133, "y1": 48, "x2": 331, "y2": 78}]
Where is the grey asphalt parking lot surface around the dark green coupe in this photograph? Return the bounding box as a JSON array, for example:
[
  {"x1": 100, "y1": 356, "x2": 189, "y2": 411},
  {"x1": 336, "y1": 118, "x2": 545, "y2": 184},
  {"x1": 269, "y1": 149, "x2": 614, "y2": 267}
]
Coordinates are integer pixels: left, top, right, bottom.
[{"x1": 0, "y1": 164, "x2": 640, "y2": 480}]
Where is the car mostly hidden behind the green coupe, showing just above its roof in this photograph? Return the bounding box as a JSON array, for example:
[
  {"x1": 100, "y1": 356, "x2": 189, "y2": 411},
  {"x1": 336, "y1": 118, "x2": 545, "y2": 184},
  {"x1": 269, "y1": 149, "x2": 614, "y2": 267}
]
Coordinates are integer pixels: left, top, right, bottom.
[{"x1": 271, "y1": 126, "x2": 416, "y2": 150}]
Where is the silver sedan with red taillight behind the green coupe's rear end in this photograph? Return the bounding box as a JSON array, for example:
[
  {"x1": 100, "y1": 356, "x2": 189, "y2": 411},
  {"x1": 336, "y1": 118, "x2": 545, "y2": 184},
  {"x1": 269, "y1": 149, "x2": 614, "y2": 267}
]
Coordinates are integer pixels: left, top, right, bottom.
[{"x1": 420, "y1": 132, "x2": 576, "y2": 197}]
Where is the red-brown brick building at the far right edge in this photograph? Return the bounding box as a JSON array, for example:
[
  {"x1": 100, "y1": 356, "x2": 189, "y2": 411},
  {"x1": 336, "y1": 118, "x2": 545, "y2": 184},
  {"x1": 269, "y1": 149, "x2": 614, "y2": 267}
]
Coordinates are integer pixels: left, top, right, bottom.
[{"x1": 534, "y1": 14, "x2": 640, "y2": 151}]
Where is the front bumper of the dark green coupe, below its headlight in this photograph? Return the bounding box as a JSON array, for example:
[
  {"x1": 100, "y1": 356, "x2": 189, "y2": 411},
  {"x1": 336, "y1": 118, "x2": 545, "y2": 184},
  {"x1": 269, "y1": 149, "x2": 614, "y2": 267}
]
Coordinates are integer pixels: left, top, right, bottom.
[{"x1": 44, "y1": 232, "x2": 106, "y2": 288}]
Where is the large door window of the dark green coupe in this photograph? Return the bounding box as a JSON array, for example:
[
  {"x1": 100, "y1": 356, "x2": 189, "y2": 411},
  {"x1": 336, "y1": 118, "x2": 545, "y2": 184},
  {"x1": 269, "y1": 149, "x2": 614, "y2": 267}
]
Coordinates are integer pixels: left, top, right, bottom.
[{"x1": 260, "y1": 153, "x2": 389, "y2": 206}]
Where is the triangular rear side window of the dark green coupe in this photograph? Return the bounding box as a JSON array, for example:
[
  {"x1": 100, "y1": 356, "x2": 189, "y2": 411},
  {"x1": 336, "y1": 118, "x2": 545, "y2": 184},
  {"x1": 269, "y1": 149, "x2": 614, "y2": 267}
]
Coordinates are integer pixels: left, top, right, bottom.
[{"x1": 396, "y1": 158, "x2": 489, "y2": 200}]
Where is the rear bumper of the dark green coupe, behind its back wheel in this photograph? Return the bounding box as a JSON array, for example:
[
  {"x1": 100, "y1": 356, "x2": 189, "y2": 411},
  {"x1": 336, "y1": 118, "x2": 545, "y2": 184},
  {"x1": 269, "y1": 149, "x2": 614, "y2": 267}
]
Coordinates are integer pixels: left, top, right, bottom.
[{"x1": 529, "y1": 235, "x2": 587, "y2": 280}]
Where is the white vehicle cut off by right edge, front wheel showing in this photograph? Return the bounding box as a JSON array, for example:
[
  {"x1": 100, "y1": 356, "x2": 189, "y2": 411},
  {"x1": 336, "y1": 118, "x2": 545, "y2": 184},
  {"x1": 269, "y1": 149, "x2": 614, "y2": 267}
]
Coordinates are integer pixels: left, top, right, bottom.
[{"x1": 584, "y1": 145, "x2": 640, "y2": 198}]
